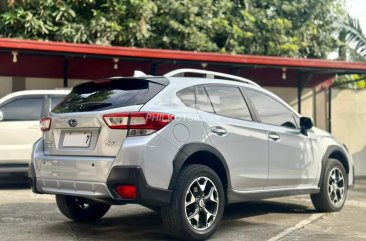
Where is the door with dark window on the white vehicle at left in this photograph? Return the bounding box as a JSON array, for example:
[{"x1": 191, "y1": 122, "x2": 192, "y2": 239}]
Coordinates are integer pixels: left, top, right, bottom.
[{"x1": 0, "y1": 96, "x2": 45, "y2": 164}]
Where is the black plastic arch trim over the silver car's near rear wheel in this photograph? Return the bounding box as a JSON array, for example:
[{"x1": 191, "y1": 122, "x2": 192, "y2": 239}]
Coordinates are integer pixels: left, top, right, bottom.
[{"x1": 169, "y1": 142, "x2": 231, "y2": 190}]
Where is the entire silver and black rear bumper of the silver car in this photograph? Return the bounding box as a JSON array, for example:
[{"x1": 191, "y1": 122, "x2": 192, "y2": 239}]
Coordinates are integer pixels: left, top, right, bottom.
[{"x1": 28, "y1": 140, "x2": 171, "y2": 206}]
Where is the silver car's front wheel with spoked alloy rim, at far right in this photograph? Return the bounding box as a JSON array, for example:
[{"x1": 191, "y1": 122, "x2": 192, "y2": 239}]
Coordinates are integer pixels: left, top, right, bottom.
[{"x1": 310, "y1": 159, "x2": 348, "y2": 212}]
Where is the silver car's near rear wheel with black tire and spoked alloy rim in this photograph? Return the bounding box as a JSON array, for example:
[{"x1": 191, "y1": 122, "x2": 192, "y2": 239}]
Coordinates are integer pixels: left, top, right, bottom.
[{"x1": 161, "y1": 165, "x2": 225, "y2": 240}]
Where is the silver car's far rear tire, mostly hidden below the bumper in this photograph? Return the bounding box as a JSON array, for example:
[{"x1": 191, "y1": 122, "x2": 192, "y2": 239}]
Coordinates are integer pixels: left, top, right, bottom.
[{"x1": 56, "y1": 195, "x2": 111, "y2": 222}]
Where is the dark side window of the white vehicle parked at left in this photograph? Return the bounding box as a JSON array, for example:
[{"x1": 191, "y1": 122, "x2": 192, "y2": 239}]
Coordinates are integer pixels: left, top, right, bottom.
[{"x1": 1, "y1": 97, "x2": 43, "y2": 121}]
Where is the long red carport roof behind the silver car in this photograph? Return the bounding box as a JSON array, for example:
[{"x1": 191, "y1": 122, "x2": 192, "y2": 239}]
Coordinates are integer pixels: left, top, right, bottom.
[{"x1": 0, "y1": 38, "x2": 366, "y2": 87}]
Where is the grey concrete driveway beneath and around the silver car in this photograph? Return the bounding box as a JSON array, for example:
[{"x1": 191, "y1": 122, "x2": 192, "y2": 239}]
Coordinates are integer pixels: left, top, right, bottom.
[{"x1": 0, "y1": 179, "x2": 366, "y2": 241}]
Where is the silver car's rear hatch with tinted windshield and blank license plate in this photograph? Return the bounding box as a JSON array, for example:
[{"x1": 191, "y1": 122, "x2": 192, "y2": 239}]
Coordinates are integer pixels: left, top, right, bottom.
[{"x1": 44, "y1": 77, "x2": 169, "y2": 156}]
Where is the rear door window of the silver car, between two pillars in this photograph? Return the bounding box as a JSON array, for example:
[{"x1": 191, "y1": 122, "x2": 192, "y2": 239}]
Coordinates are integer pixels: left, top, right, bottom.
[{"x1": 205, "y1": 86, "x2": 252, "y2": 120}]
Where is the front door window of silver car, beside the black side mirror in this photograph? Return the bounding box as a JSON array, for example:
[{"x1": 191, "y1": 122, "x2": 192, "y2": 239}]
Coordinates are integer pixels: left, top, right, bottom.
[{"x1": 247, "y1": 90, "x2": 296, "y2": 128}]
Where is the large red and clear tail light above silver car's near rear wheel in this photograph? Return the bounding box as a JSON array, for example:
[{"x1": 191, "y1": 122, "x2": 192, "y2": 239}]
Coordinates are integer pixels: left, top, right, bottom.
[{"x1": 103, "y1": 112, "x2": 175, "y2": 136}]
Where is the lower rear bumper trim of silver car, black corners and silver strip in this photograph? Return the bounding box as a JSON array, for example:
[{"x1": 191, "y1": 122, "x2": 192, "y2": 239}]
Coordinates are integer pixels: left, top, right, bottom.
[{"x1": 28, "y1": 164, "x2": 172, "y2": 206}]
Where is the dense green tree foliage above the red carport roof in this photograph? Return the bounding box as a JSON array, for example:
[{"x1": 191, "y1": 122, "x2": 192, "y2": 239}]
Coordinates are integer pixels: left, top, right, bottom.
[{"x1": 0, "y1": 0, "x2": 348, "y2": 58}]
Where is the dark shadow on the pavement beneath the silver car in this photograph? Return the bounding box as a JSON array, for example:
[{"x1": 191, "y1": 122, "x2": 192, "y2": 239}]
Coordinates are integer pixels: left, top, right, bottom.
[{"x1": 38, "y1": 201, "x2": 314, "y2": 240}]
